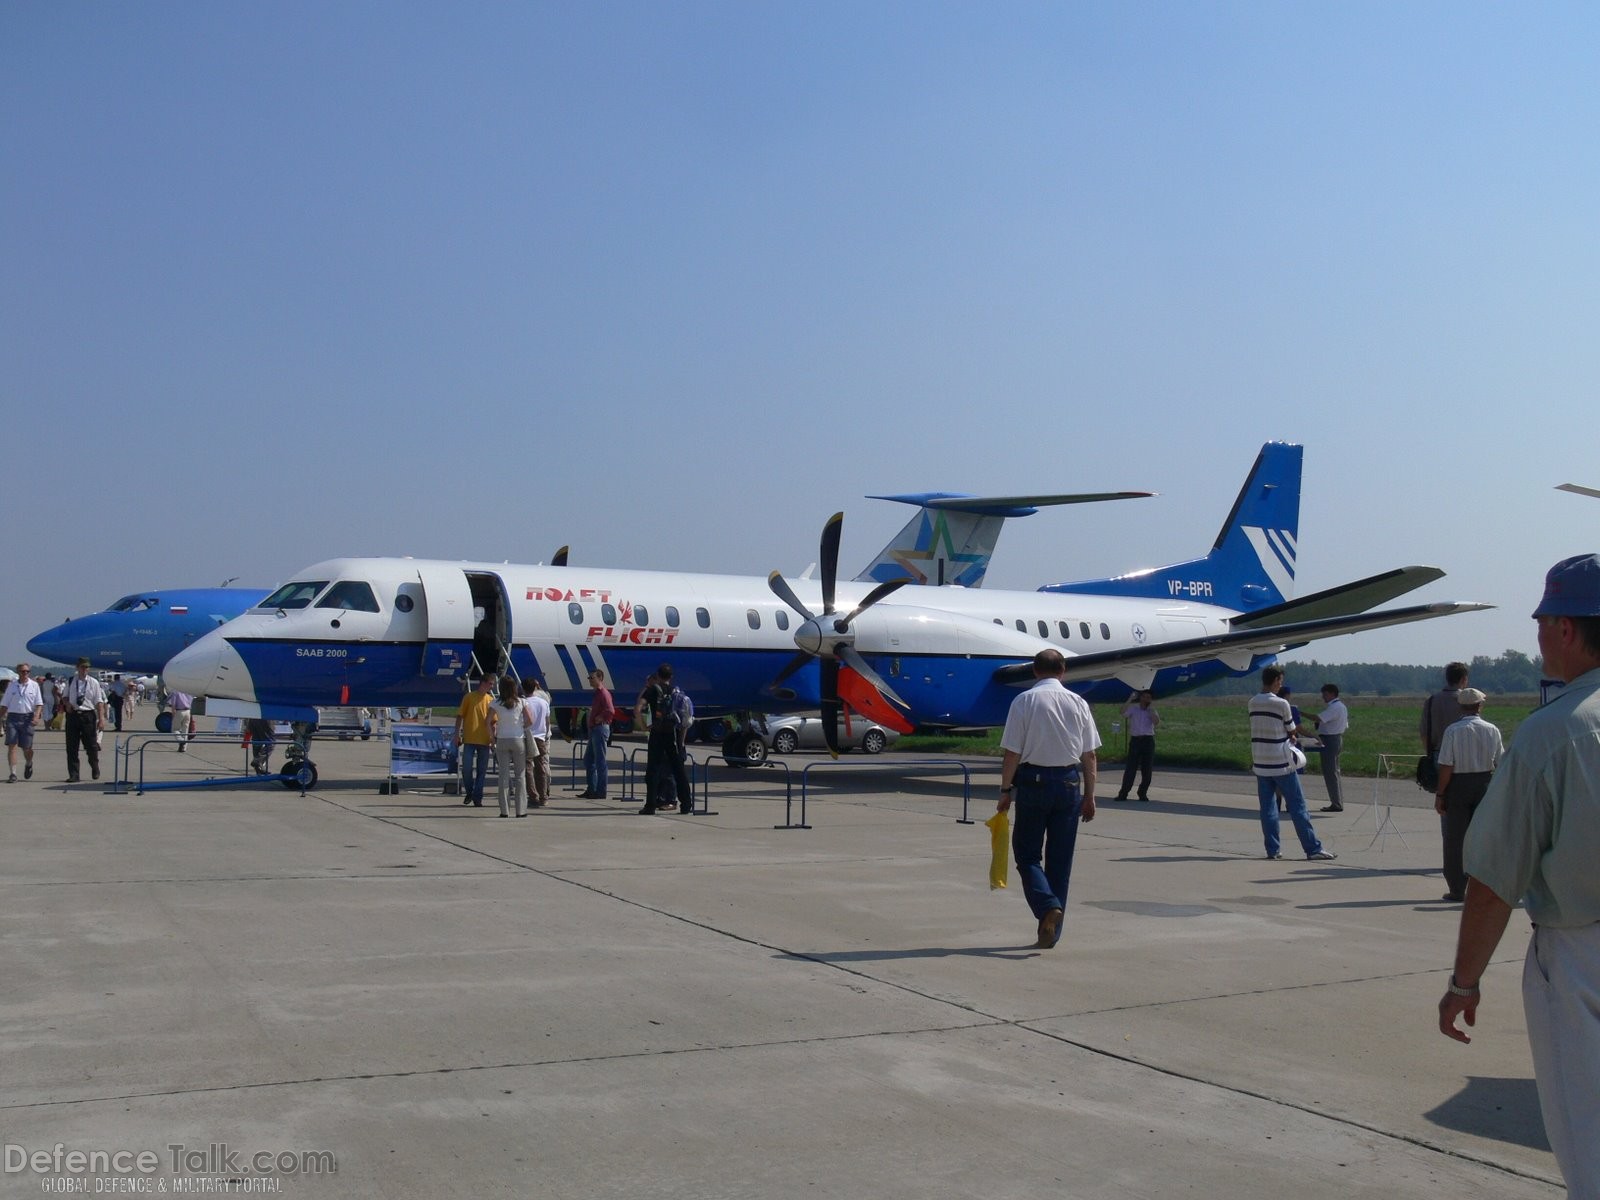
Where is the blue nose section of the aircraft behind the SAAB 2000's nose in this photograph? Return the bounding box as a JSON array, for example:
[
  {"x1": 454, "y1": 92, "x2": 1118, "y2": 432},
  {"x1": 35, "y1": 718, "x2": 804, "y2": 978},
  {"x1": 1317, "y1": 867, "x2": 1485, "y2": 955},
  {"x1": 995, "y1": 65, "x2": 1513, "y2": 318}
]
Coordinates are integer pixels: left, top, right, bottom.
[{"x1": 27, "y1": 587, "x2": 267, "y2": 675}]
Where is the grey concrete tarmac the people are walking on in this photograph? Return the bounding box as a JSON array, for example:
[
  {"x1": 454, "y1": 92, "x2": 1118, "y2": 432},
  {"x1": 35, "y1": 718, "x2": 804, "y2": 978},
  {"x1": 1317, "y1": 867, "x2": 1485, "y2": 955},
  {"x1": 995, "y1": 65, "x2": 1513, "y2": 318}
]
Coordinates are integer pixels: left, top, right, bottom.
[{"x1": 0, "y1": 710, "x2": 1563, "y2": 1200}]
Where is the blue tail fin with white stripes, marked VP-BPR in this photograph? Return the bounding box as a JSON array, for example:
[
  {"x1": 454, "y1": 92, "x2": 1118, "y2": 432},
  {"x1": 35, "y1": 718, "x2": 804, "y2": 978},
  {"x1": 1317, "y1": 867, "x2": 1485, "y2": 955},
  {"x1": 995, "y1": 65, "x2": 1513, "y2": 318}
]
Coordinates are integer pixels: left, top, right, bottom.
[{"x1": 1040, "y1": 442, "x2": 1304, "y2": 613}]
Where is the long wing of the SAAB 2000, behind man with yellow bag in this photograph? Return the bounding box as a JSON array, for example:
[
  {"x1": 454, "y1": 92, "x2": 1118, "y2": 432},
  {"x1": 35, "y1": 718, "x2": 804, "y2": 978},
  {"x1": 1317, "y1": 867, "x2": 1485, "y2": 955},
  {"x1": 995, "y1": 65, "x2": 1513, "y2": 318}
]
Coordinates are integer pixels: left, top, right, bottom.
[{"x1": 995, "y1": 600, "x2": 1494, "y2": 686}]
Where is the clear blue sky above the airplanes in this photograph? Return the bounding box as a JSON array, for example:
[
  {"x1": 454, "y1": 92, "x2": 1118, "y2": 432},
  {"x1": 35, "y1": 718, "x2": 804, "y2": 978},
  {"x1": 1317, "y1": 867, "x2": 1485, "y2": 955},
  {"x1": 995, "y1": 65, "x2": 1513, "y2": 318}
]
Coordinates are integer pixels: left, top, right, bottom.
[{"x1": 0, "y1": 0, "x2": 1600, "y2": 662}]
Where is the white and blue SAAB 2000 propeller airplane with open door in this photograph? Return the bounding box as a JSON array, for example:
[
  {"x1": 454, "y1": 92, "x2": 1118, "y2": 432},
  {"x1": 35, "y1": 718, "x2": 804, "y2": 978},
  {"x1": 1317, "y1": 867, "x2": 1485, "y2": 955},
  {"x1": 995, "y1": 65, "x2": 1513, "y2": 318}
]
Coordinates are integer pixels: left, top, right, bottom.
[{"x1": 163, "y1": 443, "x2": 1488, "y2": 752}]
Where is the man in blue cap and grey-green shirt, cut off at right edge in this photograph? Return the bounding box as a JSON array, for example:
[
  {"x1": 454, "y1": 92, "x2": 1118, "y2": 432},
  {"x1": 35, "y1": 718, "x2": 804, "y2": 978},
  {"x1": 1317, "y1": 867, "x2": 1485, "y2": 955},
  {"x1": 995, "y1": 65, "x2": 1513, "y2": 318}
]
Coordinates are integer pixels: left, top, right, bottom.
[{"x1": 1438, "y1": 554, "x2": 1600, "y2": 1197}]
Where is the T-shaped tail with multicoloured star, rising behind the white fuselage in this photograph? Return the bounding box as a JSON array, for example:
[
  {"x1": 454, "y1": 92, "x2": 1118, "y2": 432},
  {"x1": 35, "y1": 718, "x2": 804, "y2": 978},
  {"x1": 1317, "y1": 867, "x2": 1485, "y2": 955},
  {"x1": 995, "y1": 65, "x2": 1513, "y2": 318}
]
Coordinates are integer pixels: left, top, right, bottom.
[{"x1": 856, "y1": 491, "x2": 1154, "y2": 587}]
